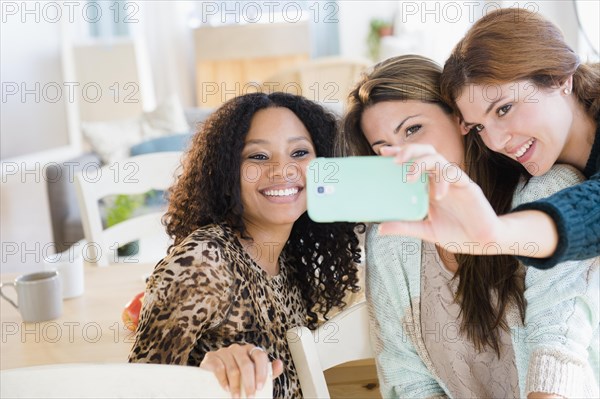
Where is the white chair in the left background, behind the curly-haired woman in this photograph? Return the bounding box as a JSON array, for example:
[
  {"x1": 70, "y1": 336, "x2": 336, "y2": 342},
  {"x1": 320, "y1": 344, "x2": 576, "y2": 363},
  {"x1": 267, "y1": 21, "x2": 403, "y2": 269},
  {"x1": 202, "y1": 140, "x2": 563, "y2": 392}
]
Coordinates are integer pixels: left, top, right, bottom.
[{"x1": 76, "y1": 152, "x2": 182, "y2": 266}]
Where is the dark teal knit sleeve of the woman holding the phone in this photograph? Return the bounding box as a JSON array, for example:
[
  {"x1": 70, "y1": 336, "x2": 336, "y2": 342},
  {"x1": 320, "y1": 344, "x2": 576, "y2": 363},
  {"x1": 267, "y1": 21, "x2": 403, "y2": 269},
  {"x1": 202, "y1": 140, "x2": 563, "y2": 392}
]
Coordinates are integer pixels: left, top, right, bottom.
[{"x1": 515, "y1": 172, "x2": 600, "y2": 269}]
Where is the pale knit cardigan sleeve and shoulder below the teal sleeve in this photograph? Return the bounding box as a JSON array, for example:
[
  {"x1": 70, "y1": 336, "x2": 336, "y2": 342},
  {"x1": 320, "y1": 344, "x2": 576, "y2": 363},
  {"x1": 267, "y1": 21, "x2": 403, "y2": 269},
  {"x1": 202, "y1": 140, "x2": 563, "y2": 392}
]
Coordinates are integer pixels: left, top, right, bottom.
[{"x1": 510, "y1": 166, "x2": 600, "y2": 397}]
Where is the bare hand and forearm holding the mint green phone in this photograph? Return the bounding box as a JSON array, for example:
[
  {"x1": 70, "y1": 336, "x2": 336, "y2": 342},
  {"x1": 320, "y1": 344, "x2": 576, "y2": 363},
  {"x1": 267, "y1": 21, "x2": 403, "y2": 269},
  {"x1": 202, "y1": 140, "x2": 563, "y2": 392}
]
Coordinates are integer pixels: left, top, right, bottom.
[{"x1": 380, "y1": 144, "x2": 558, "y2": 258}]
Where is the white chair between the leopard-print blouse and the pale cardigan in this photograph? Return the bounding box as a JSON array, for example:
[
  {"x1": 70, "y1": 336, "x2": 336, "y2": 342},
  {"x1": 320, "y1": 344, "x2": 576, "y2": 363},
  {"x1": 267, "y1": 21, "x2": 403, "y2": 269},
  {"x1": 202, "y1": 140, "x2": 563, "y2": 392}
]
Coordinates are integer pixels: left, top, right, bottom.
[{"x1": 287, "y1": 302, "x2": 374, "y2": 398}]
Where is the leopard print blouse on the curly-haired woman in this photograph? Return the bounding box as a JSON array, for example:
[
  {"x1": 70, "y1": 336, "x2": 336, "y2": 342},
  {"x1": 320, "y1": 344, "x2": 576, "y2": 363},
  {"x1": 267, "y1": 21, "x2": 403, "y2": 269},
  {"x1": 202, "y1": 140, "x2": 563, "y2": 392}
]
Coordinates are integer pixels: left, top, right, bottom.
[{"x1": 129, "y1": 225, "x2": 307, "y2": 398}]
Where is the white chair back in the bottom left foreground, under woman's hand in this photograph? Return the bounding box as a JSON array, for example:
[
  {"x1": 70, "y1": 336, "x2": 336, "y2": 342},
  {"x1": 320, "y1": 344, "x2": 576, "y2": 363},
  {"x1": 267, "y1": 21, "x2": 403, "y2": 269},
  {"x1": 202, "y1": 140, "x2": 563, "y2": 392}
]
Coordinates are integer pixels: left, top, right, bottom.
[{"x1": 0, "y1": 363, "x2": 273, "y2": 398}]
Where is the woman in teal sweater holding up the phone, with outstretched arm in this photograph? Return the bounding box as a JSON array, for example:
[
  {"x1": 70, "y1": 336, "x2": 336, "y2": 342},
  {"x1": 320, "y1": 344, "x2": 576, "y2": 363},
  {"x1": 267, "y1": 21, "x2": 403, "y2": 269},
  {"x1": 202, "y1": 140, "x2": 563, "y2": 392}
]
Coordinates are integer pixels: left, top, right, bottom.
[{"x1": 382, "y1": 8, "x2": 600, "y2": 269}]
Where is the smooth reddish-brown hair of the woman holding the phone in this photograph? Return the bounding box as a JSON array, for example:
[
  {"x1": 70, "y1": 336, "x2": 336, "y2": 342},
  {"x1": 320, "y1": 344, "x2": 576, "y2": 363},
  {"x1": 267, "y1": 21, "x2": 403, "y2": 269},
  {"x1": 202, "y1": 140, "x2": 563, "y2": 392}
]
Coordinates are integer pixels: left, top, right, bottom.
[{"x1": 440, "y1": 8, "x2": 600, "y2": 119}]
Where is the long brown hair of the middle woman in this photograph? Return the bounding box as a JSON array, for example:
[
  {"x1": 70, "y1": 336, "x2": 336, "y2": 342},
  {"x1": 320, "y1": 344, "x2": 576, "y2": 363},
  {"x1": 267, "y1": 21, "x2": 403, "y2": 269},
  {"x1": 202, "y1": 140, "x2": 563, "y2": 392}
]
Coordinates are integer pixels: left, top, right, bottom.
[{"x1": 336, "y1": 55, "x2": 525, "y2": 356}]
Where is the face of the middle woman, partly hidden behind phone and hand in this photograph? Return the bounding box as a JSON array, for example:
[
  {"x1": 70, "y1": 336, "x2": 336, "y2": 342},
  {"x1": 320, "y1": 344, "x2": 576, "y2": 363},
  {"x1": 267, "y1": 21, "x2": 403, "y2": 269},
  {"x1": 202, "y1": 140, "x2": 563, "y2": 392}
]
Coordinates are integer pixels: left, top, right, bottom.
[{"x1": 361, "y1": 100, "x2": 464, "y2": 165}]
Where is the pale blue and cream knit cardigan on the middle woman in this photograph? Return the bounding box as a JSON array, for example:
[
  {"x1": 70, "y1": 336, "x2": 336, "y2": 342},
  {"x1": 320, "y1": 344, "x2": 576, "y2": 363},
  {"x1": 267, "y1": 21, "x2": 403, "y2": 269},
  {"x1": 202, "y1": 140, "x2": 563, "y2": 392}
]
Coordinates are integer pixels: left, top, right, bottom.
[{"x1": 366, "y1": 165, "x2": 600, "y2": 398}]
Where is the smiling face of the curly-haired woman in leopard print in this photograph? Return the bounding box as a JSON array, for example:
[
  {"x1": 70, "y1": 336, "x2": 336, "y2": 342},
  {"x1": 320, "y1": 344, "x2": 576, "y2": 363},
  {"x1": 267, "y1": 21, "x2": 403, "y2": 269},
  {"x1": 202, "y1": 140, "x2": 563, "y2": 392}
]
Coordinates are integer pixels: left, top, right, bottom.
[{"x1": 241, "y1": 107, "x2": 315, "y2": 228}]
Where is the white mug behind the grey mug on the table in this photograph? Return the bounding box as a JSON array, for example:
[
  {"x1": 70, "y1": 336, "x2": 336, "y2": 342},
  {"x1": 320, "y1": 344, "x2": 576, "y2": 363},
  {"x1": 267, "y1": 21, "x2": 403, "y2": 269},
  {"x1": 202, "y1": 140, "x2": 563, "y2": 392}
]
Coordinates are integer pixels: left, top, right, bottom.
[{"x1": 44, "y1": 251, "x2": 85, "y2": 299}]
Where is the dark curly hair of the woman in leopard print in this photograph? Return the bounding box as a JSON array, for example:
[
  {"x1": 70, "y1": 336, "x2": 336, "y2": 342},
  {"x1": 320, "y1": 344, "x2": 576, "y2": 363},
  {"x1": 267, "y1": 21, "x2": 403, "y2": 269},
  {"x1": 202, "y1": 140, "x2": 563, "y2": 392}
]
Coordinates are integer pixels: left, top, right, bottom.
[{"x1": 163, "y1": 93, "x2": 364, "y2": 328}]
